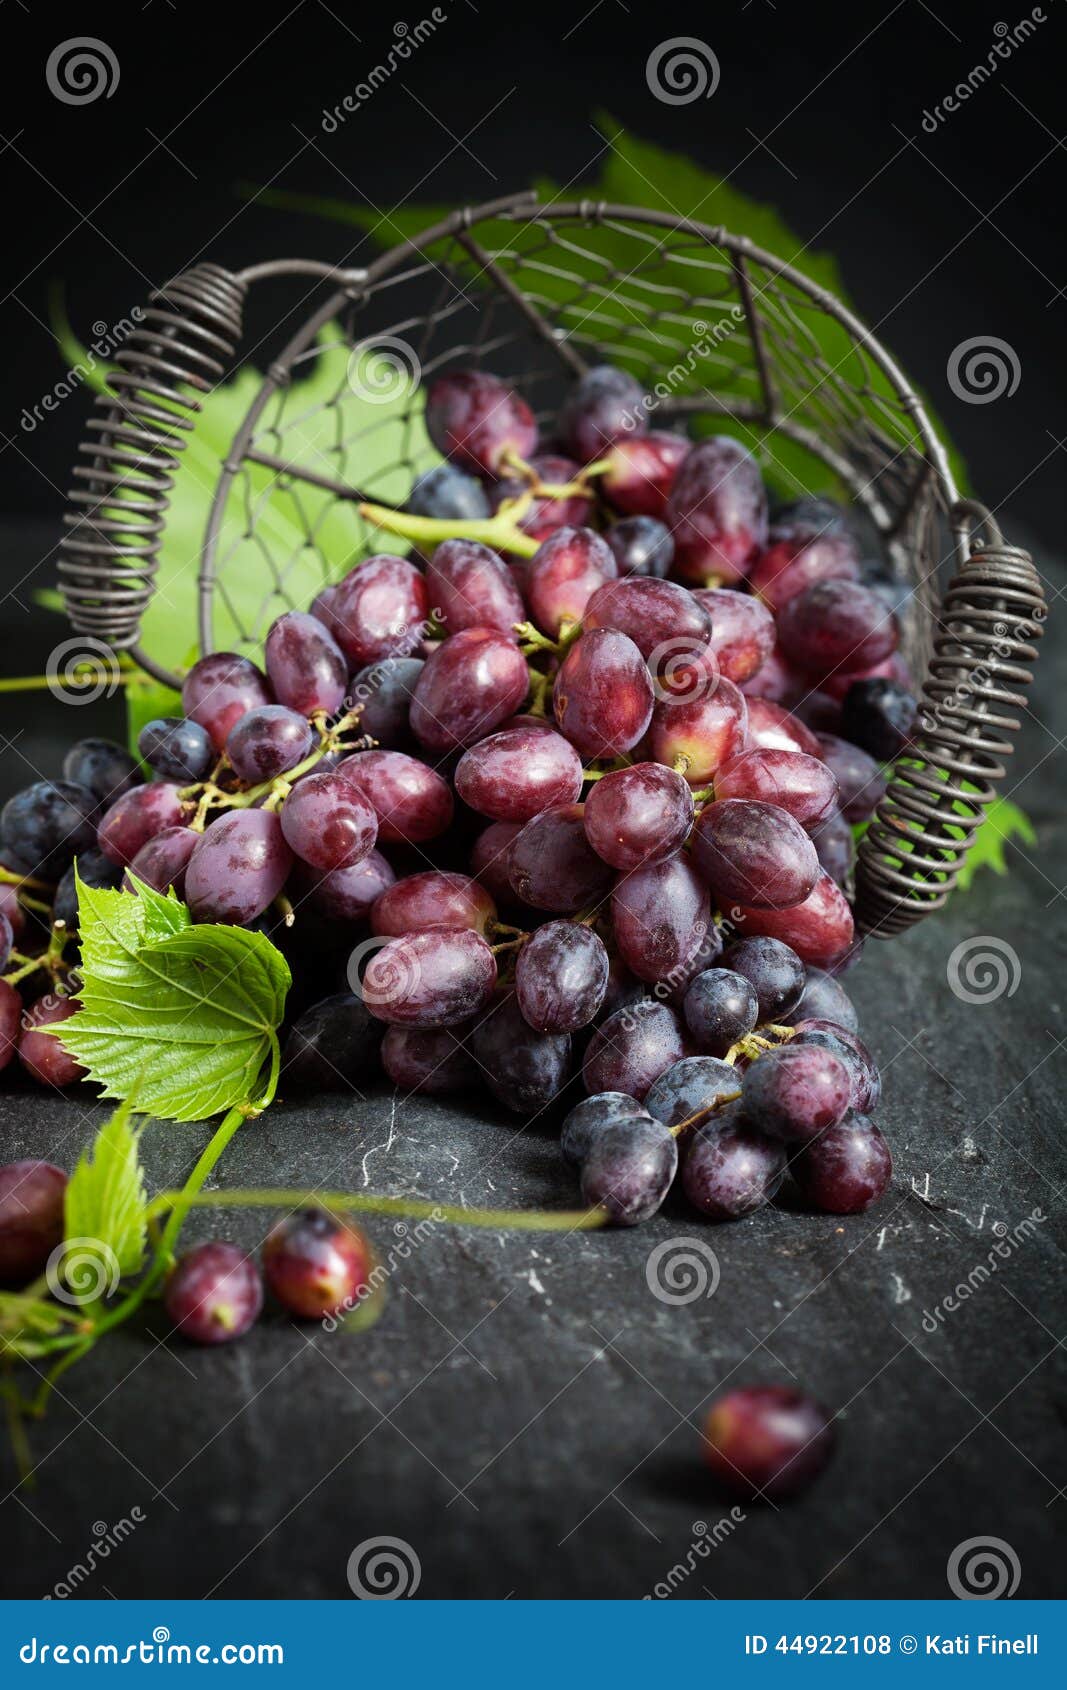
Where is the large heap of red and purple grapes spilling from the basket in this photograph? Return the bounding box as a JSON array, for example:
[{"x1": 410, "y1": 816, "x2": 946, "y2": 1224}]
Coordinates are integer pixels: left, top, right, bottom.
[{"x1": 0, "y1": 367, "x2": 915, "y2": 1257}]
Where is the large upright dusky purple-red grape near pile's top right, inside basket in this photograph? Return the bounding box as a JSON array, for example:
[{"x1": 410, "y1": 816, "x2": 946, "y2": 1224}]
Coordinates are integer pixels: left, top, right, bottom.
[{"x1": 665, "y1": 434, "x2": 768, "y2": 586}]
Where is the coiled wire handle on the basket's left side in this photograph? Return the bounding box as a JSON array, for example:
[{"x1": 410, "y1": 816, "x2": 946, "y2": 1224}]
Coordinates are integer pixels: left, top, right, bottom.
[{"x1": 57, "y1": 264, "x2": 247, "y2": 684}]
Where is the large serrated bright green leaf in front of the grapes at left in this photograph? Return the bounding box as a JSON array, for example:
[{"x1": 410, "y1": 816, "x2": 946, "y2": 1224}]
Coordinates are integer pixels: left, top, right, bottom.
[{"x1": 59, "y1": 880, "x2": 291, "y2": 1120}]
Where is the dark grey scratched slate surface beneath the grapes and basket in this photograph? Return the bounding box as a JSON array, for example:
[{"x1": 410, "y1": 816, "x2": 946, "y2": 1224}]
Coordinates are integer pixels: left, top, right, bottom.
[{"x1": 0, "y1": 517, "x2": 1067, "y2": 1599}]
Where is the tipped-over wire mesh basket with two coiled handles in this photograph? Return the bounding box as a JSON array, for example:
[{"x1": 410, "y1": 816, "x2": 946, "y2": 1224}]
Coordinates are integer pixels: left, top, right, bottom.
[{"x1": 59, "y1": 194, "x2": 1045, "y2": 936}]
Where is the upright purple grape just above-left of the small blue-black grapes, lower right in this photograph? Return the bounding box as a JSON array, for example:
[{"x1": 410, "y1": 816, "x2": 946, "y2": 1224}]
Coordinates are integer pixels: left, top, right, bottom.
[{"x1": 612, "y1": 853, "x2": 712, "y2": 982}]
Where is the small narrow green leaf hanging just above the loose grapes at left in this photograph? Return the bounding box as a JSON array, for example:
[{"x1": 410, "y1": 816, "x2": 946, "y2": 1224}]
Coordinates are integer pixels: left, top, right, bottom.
[{"x1": 63, "y1": 1099, "x2": 147, "y2": 1274}]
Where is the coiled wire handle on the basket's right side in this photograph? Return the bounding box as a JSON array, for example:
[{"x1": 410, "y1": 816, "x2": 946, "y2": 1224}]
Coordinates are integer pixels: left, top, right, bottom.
[{"x1": 856, "y1": 500, "x2": 1045, "y2": 938}]
